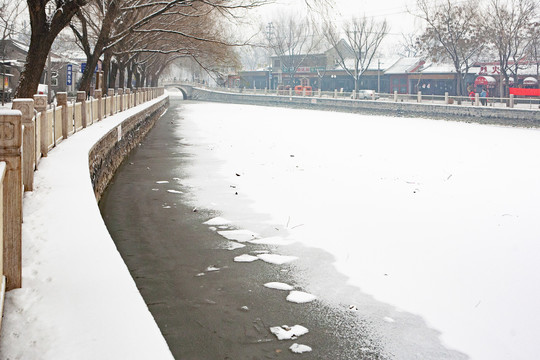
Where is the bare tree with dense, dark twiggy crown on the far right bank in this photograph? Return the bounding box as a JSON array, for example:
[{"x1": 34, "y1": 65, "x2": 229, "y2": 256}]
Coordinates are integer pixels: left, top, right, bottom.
[{"x1": 415, "y1": 0, "x2": 485, "y2": 95}]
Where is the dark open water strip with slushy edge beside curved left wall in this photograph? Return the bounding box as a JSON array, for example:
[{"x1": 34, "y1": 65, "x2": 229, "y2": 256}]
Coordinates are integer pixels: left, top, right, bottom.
[{"x1": 100, "y1": 99, "x2": 466, "y2": 359}]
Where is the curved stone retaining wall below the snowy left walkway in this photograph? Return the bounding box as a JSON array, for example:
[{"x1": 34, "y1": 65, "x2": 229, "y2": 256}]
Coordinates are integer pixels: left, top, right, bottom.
[{"x1": 88, "y1": 97, "x2": 169, "y2": 200}]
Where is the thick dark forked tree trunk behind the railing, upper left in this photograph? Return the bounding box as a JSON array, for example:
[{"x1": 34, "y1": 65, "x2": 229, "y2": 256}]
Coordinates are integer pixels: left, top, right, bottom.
[{"x1": 15, "y1": 0, "x2": 88, "y2": 98}]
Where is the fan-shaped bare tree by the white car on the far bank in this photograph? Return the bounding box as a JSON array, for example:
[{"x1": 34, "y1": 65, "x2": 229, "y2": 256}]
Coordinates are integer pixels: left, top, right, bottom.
[{"x1": 325, "y1": 16, "x2": 388, "y2": 94}]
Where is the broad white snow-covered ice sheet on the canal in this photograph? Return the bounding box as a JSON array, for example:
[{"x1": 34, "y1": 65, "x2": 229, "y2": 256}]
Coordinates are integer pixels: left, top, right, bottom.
[{"x1": 175, "y1": 104, "x2": 540, "y2": 360}]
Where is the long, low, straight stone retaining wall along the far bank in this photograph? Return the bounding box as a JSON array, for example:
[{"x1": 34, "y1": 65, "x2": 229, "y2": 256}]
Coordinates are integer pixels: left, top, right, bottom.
[{"x1": 192, "y1": 88, "x2": 540, "y2": 127}]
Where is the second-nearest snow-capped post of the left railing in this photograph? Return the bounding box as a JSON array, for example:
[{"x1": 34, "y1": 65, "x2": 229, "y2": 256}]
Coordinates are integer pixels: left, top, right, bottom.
[{"x1": 12, "y1": 99, "x2": 36, "y2": 191}]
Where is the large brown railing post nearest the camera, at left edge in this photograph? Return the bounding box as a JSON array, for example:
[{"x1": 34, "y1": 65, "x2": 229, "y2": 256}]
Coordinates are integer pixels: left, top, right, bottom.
[{"x1": 0, "y1": 110, "x2": 23, "y2": 290}]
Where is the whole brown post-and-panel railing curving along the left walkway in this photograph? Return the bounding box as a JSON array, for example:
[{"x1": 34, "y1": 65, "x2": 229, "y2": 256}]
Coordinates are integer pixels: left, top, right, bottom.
[{"x1": 0, "y1": 88, "x2": 164, "y2": 306}]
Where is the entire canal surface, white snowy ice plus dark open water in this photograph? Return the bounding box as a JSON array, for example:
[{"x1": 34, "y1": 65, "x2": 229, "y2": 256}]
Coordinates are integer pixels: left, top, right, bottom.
[{"x1": 102, "y1": 95, "x2": 540, "y2": 360}]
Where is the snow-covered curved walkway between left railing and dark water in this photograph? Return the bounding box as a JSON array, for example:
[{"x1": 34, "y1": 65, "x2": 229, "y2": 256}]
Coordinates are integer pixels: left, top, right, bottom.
[{"x1": 0, "y1": 97, "x2": 172, "y2": 360}]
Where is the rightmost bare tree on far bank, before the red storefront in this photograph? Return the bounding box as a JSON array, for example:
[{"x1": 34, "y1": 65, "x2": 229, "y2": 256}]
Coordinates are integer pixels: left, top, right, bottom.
[{"x1": 483, "y1": 0, "x2": 538, "y2": 95}]
